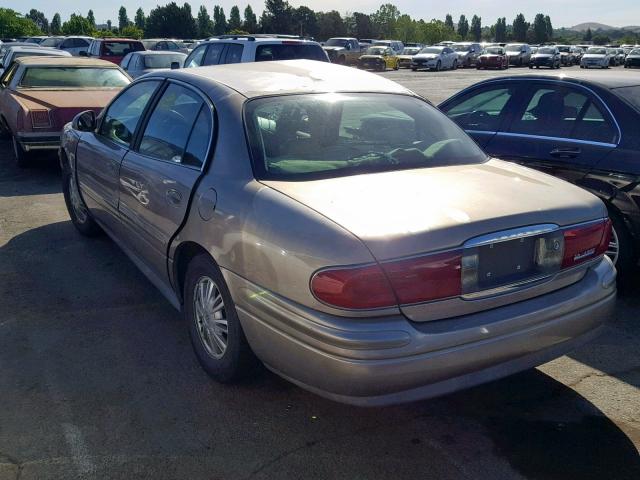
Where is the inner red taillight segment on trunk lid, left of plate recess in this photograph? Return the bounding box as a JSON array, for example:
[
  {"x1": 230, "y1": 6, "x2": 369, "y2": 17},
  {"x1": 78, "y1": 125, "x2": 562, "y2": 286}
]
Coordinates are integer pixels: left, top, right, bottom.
[{"x1": 382, "y1": 251, "x2": 462, "y2": 304}]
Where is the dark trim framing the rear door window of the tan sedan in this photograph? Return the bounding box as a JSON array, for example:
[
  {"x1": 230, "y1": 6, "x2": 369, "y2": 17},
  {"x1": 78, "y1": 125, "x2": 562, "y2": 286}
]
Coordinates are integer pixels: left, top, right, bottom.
[{"x1": 129, "y1": 79, "x2": 218, "y2": 172}]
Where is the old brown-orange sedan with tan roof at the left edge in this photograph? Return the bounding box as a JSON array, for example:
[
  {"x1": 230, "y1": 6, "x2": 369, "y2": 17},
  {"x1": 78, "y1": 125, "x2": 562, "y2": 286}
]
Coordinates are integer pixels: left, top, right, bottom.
[{"x1": 0, "y1": 57, "x2": 131, "y2": 167}]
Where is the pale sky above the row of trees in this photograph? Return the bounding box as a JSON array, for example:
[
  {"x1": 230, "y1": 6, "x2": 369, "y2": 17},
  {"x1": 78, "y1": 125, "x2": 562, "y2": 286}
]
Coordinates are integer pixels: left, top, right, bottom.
[{"x1": 1, "y1": 0, "x2": 640, "y2": 28}]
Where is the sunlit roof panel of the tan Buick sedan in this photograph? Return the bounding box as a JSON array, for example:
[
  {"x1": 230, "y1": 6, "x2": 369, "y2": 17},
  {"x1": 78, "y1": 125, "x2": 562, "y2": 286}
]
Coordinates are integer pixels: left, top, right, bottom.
[{"x1": 159, "y1": 60, "x2": 413, "y2": 98}]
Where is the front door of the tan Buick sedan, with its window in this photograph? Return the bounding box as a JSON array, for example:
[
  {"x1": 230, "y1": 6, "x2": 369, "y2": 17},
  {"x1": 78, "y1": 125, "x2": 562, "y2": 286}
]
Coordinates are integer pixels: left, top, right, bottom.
[{"x1": 76, "y1": 80, "x2": 161, "y2": 234}]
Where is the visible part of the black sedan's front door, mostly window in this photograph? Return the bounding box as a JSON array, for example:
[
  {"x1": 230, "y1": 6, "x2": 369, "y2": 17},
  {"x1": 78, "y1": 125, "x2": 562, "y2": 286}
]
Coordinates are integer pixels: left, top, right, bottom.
[{"x1": 440, "y1": 82, "x2": 524, "y2": 148}]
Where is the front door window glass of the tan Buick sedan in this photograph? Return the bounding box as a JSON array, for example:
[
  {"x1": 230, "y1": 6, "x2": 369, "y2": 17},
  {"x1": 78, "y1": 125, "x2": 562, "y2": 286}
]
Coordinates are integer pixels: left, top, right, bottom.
[{"x1": 100, "y1": 80, "x2": 160, "y2": 146}]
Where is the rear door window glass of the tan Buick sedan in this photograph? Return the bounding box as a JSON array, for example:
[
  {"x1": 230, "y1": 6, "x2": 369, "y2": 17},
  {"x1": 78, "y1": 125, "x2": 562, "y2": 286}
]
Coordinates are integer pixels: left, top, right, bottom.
[{"x1": 139, "y1": 85, "x2": 203, "y2": 164}]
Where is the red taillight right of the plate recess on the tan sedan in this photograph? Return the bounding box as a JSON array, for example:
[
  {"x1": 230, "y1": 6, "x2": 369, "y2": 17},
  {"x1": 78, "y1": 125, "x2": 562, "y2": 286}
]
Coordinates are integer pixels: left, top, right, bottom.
[{"x1": 562, "y1": 219, "x2": 611, "y2": 268}]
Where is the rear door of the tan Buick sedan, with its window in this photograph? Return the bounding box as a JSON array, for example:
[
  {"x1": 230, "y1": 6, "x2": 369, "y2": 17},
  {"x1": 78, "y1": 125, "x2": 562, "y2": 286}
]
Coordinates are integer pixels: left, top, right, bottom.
[{"x1": 119, "y1": 82, "x2": 214, "y2": 278}]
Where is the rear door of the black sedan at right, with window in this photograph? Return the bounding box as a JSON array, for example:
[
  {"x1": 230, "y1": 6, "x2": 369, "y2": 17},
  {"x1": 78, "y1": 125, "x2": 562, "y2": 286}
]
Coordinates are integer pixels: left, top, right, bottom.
[{"x1": 486, "y1": 81, "x2": 619, "y2": 183}]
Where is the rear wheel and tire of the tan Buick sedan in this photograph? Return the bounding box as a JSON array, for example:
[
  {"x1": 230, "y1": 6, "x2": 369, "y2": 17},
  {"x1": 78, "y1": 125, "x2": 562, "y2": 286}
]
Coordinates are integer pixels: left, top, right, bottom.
[{"x1": 183, "y1": 254, "x2": 260, "y2": 383}]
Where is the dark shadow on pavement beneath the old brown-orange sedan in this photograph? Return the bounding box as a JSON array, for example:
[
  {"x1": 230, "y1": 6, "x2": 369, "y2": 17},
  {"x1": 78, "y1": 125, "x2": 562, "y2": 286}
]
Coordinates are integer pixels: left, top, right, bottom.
[{"x1": 0, "y1": 141, "x2": 62, "y2": 198}]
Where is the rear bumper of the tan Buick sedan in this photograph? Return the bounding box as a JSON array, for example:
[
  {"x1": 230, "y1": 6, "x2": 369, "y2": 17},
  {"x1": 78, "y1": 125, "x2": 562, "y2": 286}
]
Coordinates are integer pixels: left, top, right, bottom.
[{"x1": 225, "y1": 259, "x2": 616, "y2": 406}]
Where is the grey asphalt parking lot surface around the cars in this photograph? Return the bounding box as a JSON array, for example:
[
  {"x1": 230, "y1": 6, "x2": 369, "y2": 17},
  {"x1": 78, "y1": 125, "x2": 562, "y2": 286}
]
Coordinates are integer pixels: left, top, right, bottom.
[{"x1": 0, "y1": 64, "x2": 640, "y2": 480}]
